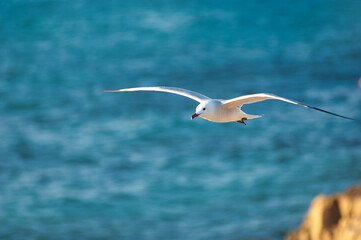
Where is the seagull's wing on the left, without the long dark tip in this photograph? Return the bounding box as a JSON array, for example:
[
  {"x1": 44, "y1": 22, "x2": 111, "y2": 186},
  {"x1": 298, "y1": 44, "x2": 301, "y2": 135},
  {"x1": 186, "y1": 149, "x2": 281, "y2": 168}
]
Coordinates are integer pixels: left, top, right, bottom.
[{"x1": 102, "y1": 87, "x2": 210, "y2": 102}]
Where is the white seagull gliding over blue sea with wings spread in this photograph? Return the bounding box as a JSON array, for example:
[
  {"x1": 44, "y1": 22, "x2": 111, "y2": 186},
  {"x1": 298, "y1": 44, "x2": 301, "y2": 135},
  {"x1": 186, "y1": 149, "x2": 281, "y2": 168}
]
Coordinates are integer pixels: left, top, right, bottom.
[{"x1": 102, "y1": 87, "x2": 354, "y2": 125}]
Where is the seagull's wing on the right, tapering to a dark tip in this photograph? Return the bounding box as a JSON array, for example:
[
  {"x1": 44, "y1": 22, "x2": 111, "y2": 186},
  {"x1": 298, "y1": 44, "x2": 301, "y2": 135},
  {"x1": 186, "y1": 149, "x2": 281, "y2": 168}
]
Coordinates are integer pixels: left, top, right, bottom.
[{"x1": 223, "y1": 93, "x2": 355, "y2": 120}]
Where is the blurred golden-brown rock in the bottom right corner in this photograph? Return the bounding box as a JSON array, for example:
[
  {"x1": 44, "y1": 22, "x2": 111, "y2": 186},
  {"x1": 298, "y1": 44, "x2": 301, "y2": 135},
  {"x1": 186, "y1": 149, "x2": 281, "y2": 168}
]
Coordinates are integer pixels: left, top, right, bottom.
[{"x1": 285, "y1": 184, "x2": 361, "y2": 240}]
